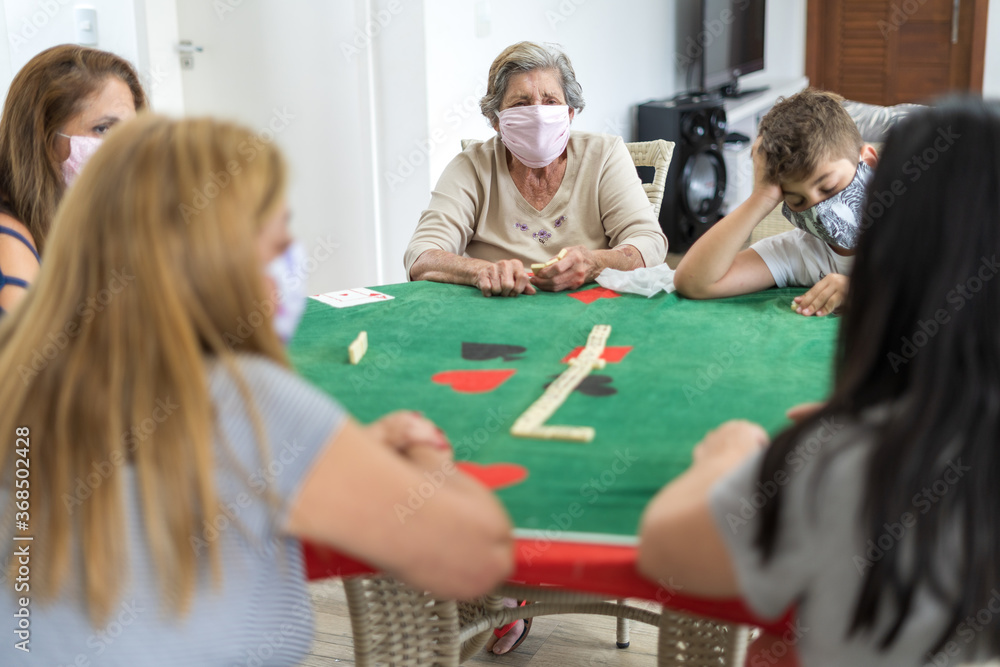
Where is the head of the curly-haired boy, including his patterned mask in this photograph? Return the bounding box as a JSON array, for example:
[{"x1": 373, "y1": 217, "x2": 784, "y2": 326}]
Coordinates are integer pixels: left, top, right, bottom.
[{"x1": 754, "y1": 88, "x2": 878, "y2": 255}]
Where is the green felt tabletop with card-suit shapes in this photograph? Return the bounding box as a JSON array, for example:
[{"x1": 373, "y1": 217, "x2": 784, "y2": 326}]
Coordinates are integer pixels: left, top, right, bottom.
[{"x1": 290, "y1": 282, "x2": 837, "y2": 544}]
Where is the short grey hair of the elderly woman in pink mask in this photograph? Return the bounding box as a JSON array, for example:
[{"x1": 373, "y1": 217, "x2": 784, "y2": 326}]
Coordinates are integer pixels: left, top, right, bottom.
[{"x1": 479, "y1": 42, "x2": 584, "y2": 126}]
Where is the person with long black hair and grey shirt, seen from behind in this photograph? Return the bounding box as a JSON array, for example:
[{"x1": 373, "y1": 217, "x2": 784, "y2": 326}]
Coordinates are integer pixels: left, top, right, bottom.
[{"x1": 639, "y1": 99, "x2": 1000, "y2": 665}]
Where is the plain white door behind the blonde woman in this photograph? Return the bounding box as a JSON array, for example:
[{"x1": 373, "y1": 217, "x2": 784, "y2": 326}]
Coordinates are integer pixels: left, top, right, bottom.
[{"x1": 170, "y1": 0, "x2": 384, "y2": 294}]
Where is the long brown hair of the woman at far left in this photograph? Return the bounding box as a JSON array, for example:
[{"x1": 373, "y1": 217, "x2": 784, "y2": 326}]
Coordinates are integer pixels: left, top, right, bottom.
[{"x1": 0, "y1": 44, "x2": 146, "y2": 252}]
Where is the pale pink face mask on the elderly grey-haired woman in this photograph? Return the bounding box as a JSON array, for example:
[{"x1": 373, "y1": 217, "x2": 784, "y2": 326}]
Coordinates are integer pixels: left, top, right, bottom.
[{"x1": 497, "y1": 104, "x2": 569, "y2": 169}]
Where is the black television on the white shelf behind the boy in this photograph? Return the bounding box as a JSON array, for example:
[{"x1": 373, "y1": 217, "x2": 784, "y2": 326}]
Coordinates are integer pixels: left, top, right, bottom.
[{"x1": 701, "y1": 0, "x2": 765, "y2": 91}]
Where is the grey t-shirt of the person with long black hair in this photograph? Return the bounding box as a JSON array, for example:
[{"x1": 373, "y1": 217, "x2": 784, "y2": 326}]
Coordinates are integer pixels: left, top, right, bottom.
[{"x1": 710, "y1": 419, "x2": 984, "y2": 667}]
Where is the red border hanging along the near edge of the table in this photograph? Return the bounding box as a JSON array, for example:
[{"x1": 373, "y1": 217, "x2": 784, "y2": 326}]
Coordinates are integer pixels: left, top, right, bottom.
[{"x1": 303, "y1": 539, "x2": 794, "y2": 636}]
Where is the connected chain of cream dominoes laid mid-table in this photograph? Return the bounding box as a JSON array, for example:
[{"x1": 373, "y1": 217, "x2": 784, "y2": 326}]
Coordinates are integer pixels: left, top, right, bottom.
[{"x1": 510, "y1": 324, "x2": 611, "y2": 442}]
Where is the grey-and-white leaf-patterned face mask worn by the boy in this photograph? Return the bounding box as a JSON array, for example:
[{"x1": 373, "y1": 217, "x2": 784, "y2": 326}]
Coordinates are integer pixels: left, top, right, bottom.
[{"x1": 781, "y1": 162, "x2": 875, "y2": 250}]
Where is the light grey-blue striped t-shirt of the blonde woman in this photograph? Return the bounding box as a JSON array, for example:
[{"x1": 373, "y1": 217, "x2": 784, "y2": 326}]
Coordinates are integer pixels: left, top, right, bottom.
[{"x1": 0, "y1": 355, "x2": 345, "y2": 667}]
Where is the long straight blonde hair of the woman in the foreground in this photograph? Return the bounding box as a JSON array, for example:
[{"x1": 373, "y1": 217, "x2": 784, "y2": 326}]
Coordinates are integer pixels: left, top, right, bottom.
[{"x1": 0, "y1": 115, "x2": 287, "y2": 627}]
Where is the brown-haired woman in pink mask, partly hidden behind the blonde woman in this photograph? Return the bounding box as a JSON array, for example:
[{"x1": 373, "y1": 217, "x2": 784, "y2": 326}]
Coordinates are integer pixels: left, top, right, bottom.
[{"x1": 0, "y1": 44, "x2": 146, "y2": 314}]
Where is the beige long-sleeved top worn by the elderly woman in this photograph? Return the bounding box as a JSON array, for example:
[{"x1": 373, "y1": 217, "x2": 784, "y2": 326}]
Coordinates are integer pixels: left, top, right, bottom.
[{"x1": 403, "y1": 132, "x2": 667, "y2": 276}]
